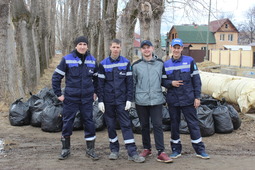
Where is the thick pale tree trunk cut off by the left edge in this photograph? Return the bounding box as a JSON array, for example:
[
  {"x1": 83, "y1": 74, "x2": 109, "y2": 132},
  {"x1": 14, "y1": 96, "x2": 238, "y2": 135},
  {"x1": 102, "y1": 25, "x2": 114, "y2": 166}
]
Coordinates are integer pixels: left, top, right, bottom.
[{"x1": 0, "y1": 0, "x2": 24, "y2": 102}]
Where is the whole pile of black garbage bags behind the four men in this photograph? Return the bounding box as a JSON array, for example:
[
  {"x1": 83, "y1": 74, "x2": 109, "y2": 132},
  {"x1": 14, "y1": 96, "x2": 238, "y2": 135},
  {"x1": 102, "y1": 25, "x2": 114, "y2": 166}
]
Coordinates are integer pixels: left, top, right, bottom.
[{"x1": 9, "y1": 88, "x2": 242, "y2": 137}]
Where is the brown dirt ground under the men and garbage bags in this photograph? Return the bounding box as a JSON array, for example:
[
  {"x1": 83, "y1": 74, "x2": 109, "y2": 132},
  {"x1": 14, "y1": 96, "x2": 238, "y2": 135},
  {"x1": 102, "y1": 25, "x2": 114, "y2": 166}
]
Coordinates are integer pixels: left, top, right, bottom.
[{"x1": 0, "y1": 55, "x2": 255, "y2": 170}]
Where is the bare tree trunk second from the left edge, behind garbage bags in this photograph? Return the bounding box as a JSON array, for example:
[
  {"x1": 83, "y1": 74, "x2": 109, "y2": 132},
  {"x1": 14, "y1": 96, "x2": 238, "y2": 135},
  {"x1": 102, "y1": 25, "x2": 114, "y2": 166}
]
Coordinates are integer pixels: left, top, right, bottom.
[{"x1": 12, "y1": 0, "x2": 38, "y2": 92}]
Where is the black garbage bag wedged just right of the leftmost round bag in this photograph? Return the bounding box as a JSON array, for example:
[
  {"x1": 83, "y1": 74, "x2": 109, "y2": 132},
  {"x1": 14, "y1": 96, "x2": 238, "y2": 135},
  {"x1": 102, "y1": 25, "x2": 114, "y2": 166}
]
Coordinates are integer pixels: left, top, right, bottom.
[{"x1": 29, "y1": 99, "x2": 47, "y2": 127}]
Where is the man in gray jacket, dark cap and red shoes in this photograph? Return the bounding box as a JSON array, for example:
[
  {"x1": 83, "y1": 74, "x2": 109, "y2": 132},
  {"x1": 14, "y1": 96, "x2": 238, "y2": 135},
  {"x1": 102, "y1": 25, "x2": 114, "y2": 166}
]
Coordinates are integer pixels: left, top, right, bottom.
[{"x1": 132, "y1": 40, "x2": 173, "y2": 163}]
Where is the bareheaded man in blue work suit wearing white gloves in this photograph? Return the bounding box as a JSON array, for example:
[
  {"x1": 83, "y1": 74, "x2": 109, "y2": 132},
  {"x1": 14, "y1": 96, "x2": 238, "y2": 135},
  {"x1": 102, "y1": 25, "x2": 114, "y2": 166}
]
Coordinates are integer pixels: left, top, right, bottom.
[{"x1": 98, "y1": 39, "x2": 145, "y2": 162}]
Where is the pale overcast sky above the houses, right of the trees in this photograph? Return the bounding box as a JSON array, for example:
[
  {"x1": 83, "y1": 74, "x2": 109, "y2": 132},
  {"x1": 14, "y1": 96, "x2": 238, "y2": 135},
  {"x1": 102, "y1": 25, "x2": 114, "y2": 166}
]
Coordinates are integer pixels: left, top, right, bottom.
[{"x1": 161, "y1": 0, "x2": 255, "y2": 34}]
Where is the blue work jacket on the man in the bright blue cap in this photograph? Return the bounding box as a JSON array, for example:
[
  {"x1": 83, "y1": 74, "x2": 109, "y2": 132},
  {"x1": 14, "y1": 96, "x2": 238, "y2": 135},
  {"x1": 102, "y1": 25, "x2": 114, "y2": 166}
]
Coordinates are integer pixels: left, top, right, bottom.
[{"x1": 162, "y1": 55, "x2": 201, "y2": 106}]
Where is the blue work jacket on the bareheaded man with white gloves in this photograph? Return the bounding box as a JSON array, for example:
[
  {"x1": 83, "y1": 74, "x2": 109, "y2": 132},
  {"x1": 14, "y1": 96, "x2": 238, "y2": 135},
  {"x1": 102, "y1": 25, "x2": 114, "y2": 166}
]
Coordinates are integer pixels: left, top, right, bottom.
[{"x1": 98, "y1": 56, "x2": 133, "y2": 105}]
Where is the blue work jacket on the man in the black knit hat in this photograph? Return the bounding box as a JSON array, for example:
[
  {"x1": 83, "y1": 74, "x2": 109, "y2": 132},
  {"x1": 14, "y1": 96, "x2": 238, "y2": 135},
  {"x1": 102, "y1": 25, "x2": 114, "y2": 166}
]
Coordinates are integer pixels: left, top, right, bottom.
[{"x1": 52, "y1": 51, "x2": 98, "y2": 103}]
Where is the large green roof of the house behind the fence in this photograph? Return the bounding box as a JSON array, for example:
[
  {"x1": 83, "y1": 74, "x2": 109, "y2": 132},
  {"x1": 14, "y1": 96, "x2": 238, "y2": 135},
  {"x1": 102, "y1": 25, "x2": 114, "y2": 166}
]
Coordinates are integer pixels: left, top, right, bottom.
[{"x1": 173, "y1": 25, "x2": 216, "y2": 44}]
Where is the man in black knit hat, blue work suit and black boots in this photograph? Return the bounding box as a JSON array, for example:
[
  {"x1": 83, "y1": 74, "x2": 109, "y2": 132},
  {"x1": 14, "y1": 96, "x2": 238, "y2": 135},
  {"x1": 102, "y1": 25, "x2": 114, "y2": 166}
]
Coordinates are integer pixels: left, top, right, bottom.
[{"x1": 52, "y1": 36, "x2": 98, "y2": 160}]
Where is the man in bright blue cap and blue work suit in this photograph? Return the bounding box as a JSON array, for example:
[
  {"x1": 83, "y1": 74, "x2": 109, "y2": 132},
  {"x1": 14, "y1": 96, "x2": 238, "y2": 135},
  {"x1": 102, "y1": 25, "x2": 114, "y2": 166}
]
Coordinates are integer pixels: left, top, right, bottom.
[{"x1": 163, "y1": 38, "x2": 210, "y2": 159}]
